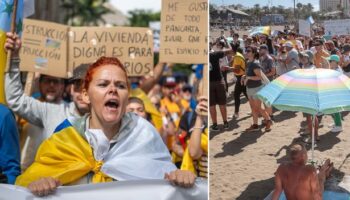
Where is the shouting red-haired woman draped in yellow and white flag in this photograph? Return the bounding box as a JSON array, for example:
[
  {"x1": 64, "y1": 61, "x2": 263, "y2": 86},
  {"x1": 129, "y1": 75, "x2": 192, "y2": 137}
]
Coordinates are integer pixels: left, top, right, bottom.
[{"x1": 16, "y1": 57, "x2": 195, "y2": 196}]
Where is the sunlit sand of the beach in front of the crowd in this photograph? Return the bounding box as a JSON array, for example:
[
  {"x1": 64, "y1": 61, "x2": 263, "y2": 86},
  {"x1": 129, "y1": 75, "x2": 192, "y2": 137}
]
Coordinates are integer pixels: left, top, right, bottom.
[{"x1": 210, "y1": 73, "x2": 350, "y2": 200}]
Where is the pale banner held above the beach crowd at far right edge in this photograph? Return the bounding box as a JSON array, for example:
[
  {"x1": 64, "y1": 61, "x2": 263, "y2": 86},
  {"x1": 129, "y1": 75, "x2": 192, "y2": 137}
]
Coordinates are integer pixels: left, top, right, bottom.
[{"x1": 324, "y1": 19, "x2": 350, "y2": 35}]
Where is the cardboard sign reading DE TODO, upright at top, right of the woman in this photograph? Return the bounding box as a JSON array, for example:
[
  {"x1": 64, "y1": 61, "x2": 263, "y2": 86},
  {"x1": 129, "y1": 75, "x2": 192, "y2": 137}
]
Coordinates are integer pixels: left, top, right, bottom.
[{"x1": 159, "y1": 0, "x2": 208, "y2": 64}]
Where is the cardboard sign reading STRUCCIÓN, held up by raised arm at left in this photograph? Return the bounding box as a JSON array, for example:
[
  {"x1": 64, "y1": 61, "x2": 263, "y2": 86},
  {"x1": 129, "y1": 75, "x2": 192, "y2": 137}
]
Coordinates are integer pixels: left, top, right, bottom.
[{"x1": 20, "y1": 19, "x2": 69, "y2": 78}]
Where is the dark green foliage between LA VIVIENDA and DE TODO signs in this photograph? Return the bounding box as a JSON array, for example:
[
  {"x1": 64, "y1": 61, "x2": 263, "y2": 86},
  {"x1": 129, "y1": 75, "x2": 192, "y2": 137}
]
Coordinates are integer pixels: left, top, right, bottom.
[{"x1": 129, "y1": 9, "x2": 160, "y2": 27}]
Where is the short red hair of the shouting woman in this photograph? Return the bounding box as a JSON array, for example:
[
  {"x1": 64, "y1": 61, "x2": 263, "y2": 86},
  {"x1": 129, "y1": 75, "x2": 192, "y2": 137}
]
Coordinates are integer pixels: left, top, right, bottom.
[{"x1": 83, "y1": 56, "x2": 129, "y2": 90}]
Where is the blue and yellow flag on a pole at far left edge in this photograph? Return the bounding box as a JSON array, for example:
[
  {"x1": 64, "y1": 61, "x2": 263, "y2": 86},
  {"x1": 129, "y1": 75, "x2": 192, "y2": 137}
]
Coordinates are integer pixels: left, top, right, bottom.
[{"x1": 0, "y1": 0, "x2": 34, "y2": 103}]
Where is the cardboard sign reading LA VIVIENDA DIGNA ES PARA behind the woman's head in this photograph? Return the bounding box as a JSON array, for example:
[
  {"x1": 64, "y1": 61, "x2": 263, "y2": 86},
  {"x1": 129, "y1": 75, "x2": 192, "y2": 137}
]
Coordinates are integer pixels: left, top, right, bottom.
[{"x1": 68, "y1": 27, "x2": 153, "y2": 76}]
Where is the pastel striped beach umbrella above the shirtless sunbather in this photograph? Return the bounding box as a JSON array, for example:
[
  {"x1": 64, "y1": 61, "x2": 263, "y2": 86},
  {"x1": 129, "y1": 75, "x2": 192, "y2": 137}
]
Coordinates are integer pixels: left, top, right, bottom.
[{"x1": 257, "y1": 69, "x2": 350, "y2": 159}]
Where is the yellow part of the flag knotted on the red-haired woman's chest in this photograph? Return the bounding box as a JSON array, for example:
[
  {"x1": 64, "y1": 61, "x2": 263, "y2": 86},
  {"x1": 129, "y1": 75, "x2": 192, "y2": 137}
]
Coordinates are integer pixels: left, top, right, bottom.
[{"x1": 16, "y1": 120, "x2": 112, "y2": 187}]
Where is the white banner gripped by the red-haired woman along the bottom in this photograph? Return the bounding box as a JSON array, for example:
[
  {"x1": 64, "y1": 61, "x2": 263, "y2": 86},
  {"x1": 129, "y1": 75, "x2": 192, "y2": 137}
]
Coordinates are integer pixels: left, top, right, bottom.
[{"x1": 0, "y1": 179, "x2": 208, "y2": 200}]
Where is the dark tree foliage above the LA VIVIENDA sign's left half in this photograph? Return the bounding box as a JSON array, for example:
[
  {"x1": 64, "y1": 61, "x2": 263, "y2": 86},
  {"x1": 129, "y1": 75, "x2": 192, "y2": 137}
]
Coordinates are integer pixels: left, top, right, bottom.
[{"x1": 61, "y1": 0, "x2": 112, "y2": 26}]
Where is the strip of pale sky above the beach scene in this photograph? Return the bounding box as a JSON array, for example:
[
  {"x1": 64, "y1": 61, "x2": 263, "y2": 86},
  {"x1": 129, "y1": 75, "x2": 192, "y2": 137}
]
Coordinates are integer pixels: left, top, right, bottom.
[{"x1": 209, "y1": 0, "x2": 320, "y2": 10}]
